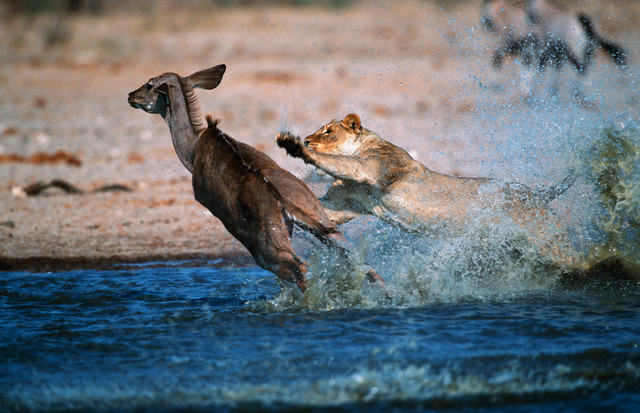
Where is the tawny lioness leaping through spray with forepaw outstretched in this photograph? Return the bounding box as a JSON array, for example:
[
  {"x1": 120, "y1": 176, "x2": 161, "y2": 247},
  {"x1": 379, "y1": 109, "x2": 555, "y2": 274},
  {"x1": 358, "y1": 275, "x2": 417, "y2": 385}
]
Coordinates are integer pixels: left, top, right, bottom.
[{"x1": 276, "y1": 113, "x2": 576, "y2": 266}]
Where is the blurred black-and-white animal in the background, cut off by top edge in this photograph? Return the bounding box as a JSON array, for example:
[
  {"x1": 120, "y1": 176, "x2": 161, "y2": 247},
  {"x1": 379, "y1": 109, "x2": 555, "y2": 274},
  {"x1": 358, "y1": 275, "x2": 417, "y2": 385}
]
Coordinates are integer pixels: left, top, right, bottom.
[{"x1": 482, "y1": 0, "x2": 628, "y2": 106}]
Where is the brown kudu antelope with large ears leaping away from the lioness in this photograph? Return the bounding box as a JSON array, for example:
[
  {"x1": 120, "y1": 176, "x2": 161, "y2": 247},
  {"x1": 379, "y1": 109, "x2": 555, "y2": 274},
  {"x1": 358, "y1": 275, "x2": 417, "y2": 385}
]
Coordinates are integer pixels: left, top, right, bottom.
[{"x1": 128, "y1": 65, "x2": 382, "y2": 292}]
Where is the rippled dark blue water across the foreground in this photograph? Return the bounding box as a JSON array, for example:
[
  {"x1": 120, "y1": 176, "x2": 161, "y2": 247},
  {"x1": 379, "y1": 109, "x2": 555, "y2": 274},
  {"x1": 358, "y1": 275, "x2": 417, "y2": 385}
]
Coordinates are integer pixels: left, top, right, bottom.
[{"x1": 0, "y1": 262, "x2": 640, "y2": 412}]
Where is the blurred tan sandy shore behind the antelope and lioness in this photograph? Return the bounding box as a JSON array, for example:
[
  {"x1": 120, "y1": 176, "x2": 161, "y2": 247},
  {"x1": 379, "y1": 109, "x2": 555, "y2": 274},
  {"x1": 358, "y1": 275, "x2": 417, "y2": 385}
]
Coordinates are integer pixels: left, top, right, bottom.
[{"x1": 0, "y1": 1, "x2": 640, "y2": 271}]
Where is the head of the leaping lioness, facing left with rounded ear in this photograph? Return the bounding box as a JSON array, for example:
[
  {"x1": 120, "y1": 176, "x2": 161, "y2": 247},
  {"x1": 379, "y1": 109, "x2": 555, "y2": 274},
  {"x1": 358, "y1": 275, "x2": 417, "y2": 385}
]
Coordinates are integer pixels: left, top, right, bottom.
[{"x1": 304, "y1": 113, "x2": 363, "y2": 155}]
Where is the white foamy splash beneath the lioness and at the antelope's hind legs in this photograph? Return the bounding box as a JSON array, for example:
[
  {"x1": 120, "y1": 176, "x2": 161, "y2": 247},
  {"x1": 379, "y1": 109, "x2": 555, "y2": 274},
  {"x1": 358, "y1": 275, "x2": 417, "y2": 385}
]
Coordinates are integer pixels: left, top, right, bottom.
[{"x1": 253, "y1": 214, "x2": 564, "y2": 312}]
